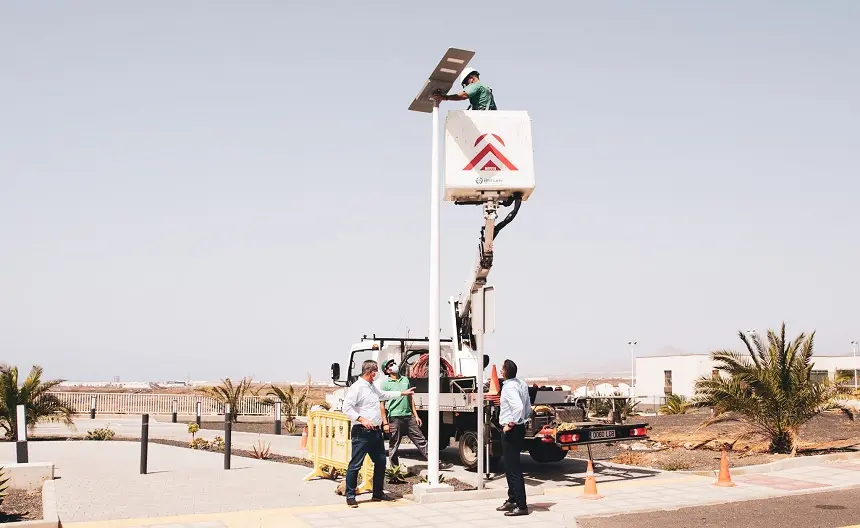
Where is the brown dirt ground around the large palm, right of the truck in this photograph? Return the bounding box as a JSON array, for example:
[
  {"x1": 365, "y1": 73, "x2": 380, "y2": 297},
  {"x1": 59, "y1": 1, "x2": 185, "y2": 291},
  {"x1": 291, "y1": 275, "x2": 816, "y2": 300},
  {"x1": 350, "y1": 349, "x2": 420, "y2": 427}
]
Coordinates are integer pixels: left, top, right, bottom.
[{"x1": 568, "y1": 412, "x2": 860, "y2": 471}]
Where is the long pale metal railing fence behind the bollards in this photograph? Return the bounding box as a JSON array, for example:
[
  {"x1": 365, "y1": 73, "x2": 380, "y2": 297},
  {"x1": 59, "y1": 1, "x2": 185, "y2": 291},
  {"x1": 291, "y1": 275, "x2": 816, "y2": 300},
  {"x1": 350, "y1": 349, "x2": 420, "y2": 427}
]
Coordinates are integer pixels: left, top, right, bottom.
[{"x1": 51, "y1": 392, "x2": 275, "y2": 416}]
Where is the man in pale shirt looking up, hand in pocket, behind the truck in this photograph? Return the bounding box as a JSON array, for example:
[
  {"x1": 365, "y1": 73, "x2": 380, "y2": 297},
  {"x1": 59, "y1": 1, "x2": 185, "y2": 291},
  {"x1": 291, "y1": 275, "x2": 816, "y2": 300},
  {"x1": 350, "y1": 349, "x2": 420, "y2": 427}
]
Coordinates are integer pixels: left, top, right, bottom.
[{"x1": 496, "y1": 359, "x2": 532, "y2": 517}]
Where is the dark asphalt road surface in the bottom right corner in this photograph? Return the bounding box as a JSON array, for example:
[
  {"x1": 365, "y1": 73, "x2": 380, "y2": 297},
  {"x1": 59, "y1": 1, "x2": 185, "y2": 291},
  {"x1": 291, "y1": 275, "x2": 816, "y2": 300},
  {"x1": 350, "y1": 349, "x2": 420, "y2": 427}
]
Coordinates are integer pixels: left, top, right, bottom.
[{"x1": 576, "y1": 488, "x2": 860, "y2": 528}]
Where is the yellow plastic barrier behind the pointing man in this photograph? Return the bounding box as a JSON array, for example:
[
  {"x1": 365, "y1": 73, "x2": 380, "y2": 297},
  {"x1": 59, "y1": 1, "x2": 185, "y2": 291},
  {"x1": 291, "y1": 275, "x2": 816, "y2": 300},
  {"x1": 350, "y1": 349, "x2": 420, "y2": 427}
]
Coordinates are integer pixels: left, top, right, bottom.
[{"x1": 304, "y1": 411, "x2": 373, "y2": 493}]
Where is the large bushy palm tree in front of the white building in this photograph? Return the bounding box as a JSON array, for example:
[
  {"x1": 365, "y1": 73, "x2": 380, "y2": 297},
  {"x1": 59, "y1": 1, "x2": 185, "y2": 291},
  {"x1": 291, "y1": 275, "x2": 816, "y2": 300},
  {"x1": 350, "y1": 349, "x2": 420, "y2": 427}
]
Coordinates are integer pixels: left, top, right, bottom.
[{"x1": 692, "y1": 323, "x2": 854, "y2": 455}]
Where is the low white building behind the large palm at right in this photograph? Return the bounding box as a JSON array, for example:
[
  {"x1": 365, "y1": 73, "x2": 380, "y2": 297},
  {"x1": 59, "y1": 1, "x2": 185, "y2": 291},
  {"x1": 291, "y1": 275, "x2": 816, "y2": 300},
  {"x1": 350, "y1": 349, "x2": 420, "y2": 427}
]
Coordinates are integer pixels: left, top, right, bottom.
[{"x1": 636, "y1": 353, "x2": 860, "y2": 403}]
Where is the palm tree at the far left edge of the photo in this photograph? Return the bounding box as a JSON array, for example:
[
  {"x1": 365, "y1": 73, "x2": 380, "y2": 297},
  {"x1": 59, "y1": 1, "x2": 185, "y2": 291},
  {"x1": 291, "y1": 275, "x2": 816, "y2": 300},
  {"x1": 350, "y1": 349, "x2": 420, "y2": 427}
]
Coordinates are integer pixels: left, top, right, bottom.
[{"x1": 0, "y1": 365, "x2": 74, "y2": 438}]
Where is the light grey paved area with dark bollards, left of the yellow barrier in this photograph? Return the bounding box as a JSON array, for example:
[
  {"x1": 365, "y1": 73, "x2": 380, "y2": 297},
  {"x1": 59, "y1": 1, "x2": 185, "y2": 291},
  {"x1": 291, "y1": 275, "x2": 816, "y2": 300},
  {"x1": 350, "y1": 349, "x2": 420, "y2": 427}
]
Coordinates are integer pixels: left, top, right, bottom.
[{"x1": 0, "y1": 441, "x2": 343, "y2": 525}]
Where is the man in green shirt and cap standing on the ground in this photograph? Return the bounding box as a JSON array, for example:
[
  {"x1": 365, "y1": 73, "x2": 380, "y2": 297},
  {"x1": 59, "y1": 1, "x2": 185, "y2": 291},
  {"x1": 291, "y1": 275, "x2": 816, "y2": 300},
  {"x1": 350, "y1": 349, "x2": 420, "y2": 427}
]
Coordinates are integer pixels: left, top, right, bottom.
[{"x1": 379, "y1": 359, "x2": 452, "y2": 469}]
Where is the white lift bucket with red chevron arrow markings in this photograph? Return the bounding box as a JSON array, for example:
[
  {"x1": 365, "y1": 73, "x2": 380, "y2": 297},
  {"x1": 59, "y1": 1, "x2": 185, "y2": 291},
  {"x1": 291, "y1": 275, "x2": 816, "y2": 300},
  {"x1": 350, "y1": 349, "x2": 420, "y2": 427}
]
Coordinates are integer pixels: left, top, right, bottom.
[{"x1": 445, "y1": 110, "x2": 535, "y2": 203}]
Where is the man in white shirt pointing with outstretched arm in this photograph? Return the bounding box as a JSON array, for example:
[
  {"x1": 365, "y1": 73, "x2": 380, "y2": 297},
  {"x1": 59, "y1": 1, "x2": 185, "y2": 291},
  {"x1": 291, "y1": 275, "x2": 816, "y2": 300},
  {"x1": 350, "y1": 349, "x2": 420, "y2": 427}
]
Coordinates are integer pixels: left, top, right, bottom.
[{"x1": 343, "y1": 359, "x2": 415, "y2": 508}]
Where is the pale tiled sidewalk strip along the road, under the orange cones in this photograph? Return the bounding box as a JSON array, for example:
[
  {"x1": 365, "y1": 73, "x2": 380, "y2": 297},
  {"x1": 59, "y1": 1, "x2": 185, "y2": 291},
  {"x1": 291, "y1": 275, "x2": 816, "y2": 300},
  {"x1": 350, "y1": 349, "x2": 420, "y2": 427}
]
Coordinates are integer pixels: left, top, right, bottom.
[{"x1": 57, "y1": 460, "x2": 860, "y2": 528}]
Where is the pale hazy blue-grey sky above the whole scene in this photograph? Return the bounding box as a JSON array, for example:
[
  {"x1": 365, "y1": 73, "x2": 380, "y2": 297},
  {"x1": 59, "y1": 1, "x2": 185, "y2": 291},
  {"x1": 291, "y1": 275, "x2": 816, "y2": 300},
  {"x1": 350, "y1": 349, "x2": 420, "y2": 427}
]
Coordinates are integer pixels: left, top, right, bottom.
[{"x1": 0, "y1": 0, "x2": 860, "y2": 381}]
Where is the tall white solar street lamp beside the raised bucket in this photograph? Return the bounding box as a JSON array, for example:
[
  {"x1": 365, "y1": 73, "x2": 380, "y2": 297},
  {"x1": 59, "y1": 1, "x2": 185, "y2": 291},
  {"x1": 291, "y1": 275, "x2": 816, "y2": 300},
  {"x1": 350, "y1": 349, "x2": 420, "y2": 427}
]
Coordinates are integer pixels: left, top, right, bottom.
[{"x1": 409, "y1": 48, "x2": 480, "y2": 487}]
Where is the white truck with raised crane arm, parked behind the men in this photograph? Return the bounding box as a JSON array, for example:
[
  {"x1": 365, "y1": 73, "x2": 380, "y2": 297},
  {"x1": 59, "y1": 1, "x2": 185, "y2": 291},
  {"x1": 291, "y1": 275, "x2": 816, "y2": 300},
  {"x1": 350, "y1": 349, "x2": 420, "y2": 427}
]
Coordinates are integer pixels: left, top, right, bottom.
[{"x1": 327, "y1": 197, "x2": 647, "y2": 469}]
